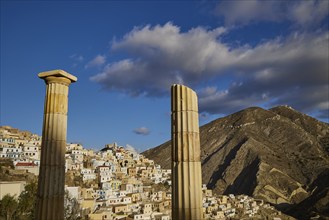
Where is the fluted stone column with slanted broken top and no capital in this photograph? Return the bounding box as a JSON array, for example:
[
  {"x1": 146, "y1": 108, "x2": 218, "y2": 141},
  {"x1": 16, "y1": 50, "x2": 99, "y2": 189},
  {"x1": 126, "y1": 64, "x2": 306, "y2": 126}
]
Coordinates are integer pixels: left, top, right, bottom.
[{"x1": 171, "y1": 85, "x2": 203, "y2": 220}]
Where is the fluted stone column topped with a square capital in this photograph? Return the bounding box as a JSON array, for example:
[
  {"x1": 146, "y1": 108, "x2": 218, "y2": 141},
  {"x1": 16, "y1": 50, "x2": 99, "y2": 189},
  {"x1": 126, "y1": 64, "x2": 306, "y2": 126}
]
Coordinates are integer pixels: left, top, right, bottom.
[{"x1": 36, "y1": 70, "x2": 77, "y2": 220}]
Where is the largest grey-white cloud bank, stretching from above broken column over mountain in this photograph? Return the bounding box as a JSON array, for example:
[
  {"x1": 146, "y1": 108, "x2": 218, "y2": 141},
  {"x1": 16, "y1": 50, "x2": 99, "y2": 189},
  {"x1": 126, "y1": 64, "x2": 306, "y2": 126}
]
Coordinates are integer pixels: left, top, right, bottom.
[{"x1": 91, "y1": 23, "x2": 329, "y2": 120}]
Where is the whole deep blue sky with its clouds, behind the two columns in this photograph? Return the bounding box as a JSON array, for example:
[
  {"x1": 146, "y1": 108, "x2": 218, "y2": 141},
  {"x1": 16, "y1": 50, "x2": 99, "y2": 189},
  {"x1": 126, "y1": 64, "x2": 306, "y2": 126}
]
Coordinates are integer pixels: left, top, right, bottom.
[{"x1": 0, "y1": 0, "x2": 329, "y2": 151}]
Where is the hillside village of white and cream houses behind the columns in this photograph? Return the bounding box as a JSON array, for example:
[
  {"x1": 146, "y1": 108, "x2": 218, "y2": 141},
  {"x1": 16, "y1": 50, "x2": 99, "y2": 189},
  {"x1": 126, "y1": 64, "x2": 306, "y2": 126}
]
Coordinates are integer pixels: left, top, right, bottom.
[{"x1": 0, "y1": 126, "x2": 293, "y2": 220}]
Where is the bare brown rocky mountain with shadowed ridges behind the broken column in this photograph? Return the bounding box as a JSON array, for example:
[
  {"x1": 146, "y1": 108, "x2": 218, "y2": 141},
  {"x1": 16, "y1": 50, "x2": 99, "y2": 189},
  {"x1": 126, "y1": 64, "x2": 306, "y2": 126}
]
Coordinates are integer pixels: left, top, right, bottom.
[{"x1": 143, "y1": 106, "x2": 329, "y2": 219}]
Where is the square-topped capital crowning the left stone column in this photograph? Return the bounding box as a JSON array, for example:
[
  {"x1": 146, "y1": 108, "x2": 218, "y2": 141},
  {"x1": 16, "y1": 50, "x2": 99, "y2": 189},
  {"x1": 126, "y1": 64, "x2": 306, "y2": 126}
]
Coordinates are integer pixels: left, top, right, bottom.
[{"x1": 38, "y1": 70, "x2": 78, "y2": 85}]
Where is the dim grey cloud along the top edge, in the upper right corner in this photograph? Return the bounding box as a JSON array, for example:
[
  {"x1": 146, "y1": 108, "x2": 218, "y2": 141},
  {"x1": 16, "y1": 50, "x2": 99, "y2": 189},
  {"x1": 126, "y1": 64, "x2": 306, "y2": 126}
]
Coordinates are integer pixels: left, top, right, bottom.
[{"x1": 215, "y1": 0, "x2": 329, "y2": 28}]
